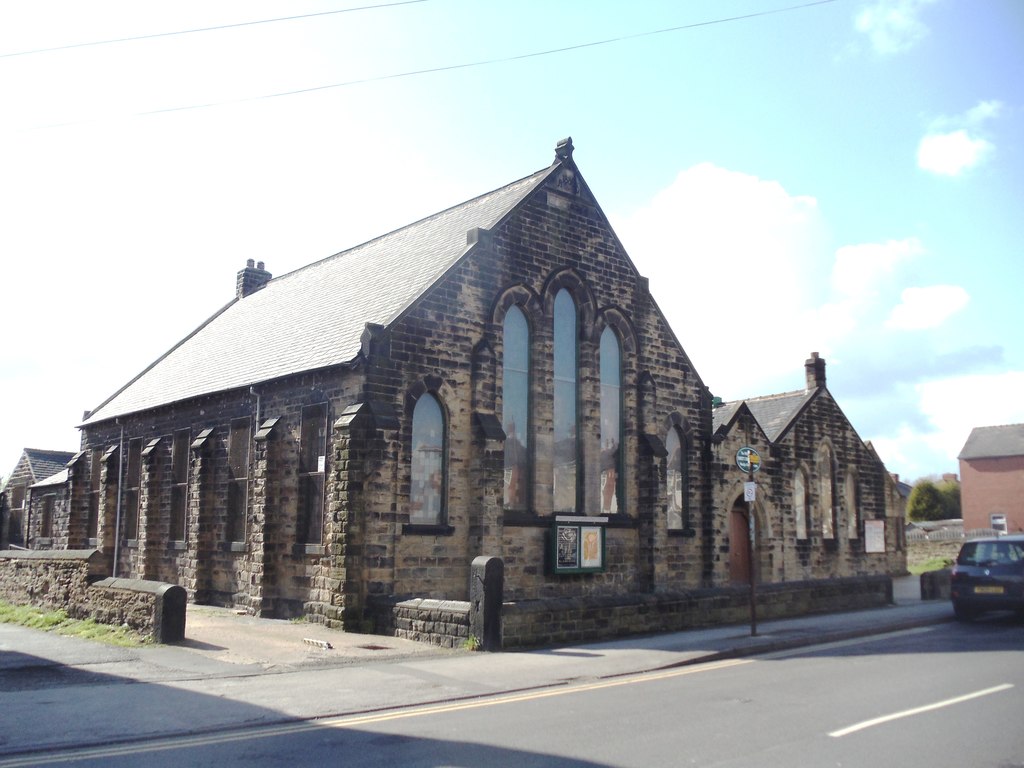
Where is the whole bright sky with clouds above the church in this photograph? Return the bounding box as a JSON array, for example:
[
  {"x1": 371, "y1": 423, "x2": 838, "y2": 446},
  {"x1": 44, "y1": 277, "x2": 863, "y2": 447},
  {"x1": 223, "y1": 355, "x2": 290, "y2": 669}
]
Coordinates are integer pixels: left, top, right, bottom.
[{"x1": 0, "y1": 0, "x2": 1024, "y2": 481}]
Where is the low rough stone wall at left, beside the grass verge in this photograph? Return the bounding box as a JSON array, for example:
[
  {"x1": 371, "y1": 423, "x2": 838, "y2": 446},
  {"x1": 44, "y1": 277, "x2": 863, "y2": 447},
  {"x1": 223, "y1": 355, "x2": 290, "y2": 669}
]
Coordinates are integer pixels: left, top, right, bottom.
[{"x1": 0, "y1": 550, "x2": 187, "y2": 643}]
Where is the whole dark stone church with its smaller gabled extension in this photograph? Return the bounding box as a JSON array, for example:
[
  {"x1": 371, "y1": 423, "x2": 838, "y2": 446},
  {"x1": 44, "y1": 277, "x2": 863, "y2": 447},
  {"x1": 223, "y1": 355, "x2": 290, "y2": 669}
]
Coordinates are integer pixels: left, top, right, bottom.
[{"x1": 6, "y1": 139, "x2": 905, "y2": 643}]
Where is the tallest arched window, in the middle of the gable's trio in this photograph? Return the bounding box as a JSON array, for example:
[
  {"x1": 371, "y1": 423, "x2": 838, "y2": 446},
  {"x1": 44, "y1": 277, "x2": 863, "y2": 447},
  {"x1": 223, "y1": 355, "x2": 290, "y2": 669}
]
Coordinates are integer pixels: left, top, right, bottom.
[{"x1": 552, "y1": 288, "x2": 579, "y2": 513}]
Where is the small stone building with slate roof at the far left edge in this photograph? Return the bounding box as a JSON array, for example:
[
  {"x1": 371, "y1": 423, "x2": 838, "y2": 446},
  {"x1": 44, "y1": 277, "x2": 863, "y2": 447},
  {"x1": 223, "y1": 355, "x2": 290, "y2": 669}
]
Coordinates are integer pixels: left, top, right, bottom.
[{"x1": 0, "y1": 449, "x2": 75, "y2": 549}]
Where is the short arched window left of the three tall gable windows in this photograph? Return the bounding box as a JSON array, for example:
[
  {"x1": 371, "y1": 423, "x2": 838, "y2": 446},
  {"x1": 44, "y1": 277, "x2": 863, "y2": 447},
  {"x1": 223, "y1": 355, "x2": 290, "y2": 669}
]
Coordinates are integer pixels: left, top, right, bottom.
[{"x1": 409, "y1": 392, "x2": 447, "y2": 525}]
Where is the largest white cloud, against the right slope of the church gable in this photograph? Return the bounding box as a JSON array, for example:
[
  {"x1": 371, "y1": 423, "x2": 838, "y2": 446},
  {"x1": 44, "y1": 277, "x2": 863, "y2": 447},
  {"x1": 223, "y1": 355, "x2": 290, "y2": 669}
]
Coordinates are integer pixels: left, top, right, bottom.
[{"x1": 613, "y1": 163, "x2": 828, "y2": 397}]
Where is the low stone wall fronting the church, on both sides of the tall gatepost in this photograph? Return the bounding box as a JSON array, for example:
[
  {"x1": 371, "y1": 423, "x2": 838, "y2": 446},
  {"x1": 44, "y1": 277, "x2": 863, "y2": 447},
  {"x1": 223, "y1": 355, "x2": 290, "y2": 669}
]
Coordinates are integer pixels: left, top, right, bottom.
[{"x1": 370, "y1": 575, "x2": 893, "y2": 648}]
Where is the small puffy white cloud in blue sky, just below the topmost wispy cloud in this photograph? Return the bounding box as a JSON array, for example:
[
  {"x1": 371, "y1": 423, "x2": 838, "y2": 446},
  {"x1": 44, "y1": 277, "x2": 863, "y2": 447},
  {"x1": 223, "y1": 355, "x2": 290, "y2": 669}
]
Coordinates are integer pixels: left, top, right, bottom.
[{"x1": 918, "y1": 100, "x2": 1002, "y2": 176}]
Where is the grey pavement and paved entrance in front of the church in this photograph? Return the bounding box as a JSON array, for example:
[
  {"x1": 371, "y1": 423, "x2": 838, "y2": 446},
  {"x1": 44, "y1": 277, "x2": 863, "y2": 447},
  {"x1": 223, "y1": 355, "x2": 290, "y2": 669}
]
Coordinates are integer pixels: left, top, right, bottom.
[{"x1": 0, "y1": 577, "x2": 953, "y2": 768}]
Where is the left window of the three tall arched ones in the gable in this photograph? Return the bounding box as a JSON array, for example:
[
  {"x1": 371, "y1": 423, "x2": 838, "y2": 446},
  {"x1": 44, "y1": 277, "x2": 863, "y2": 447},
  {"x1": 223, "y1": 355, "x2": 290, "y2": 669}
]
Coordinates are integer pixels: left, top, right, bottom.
[{"x1": 502, "y1": 306, "x2": 530, "y2": 510}]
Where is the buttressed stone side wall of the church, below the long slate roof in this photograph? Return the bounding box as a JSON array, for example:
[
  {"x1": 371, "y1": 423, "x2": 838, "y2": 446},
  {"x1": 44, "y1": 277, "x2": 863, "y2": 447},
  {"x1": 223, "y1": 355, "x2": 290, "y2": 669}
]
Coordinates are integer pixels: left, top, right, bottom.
[{"x1": 80, "y1": 370, "x2": 356, "y2": 618}]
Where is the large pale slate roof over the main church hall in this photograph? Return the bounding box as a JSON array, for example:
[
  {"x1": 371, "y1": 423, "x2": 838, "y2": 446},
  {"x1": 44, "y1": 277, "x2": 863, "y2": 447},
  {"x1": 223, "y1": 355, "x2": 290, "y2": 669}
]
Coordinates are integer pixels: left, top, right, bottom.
[{"x1": 84, "y1": 162, "x2": 561, "y2": 424}]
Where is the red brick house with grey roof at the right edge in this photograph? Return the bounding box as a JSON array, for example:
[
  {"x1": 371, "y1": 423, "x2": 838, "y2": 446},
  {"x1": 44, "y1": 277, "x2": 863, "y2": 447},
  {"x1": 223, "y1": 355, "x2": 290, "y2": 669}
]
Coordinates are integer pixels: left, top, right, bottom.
[{"x1": 958, "y1": 424, "x2": 1024, "y2": 532}]
